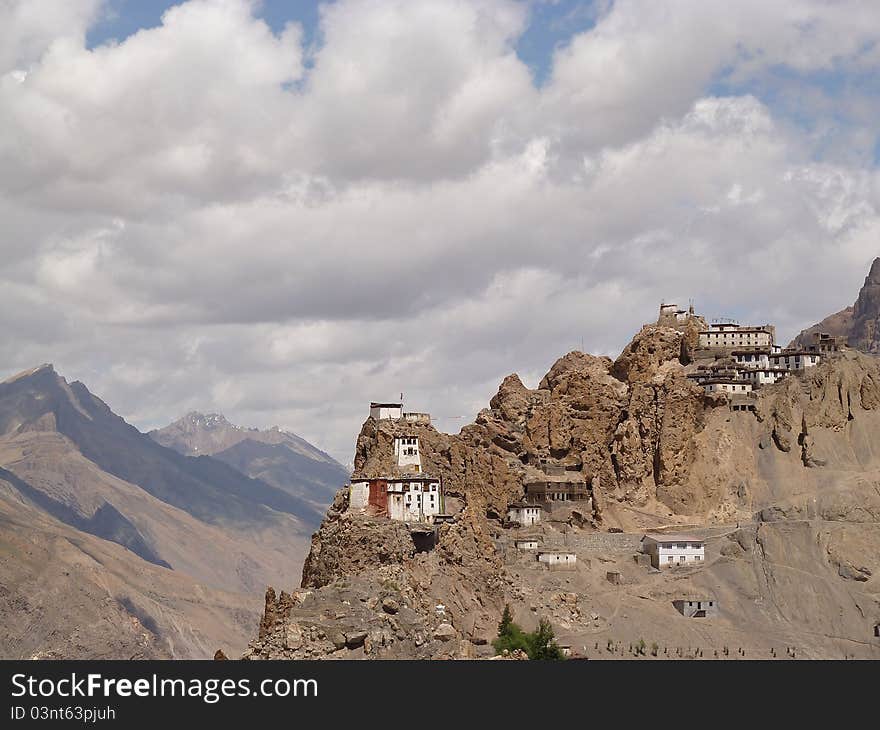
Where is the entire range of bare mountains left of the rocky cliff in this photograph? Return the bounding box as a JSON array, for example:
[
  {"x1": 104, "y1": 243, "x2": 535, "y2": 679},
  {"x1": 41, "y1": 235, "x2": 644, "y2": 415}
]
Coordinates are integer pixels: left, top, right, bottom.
[{"x1": 0, "y1": 365, "x2": 347, "y2": 658}]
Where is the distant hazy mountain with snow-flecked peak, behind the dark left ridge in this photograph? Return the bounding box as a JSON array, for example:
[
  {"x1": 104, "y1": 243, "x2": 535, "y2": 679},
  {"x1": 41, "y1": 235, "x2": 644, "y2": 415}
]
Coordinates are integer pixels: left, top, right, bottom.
[{"x1": 149, "y1": 411, "x2": 349, "y2": 512}]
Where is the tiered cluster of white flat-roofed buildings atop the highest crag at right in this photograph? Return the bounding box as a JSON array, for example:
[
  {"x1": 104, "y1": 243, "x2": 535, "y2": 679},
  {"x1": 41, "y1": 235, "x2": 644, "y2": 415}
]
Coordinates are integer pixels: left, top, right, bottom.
[{"x1": 657, "y1": 304, "x2": 845, "y2": 410}]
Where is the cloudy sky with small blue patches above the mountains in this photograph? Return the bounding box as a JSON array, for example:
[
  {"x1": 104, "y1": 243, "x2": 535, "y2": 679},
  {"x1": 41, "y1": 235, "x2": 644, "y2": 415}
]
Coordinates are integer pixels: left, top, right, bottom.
[{"x1": 0, "y1": 0, "x2": 880, "y2": 462}]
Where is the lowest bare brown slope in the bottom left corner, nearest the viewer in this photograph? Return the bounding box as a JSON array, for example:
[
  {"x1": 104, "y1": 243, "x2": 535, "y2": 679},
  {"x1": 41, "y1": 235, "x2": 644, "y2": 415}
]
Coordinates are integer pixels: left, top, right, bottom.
[{"x1": 0, "y1": 478, "x2": 259, "y2": 659}]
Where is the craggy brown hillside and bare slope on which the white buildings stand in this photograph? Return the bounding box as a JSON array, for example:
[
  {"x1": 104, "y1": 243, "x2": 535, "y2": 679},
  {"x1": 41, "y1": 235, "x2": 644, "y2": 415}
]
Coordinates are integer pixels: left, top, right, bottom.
[{"x1": 247, "y1": 326, "x2": 880, "y2": 658}]
